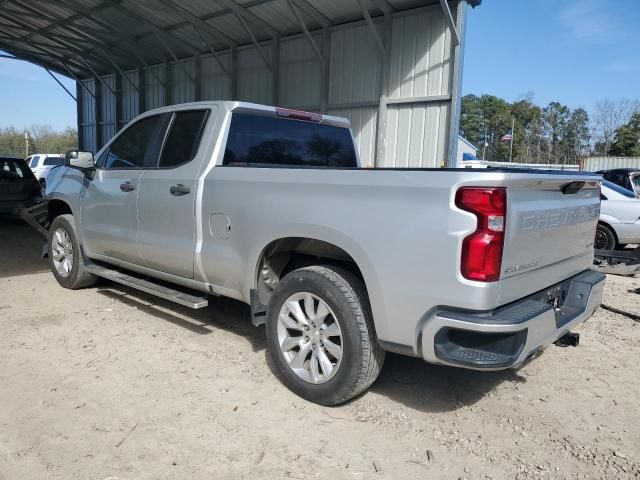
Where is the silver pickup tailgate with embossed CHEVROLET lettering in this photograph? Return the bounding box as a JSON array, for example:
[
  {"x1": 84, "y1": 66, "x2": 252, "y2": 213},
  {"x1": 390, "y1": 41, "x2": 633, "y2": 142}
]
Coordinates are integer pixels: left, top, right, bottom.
[{"x1": 498, "y1": 173, "x2": 600, "y2": 304}]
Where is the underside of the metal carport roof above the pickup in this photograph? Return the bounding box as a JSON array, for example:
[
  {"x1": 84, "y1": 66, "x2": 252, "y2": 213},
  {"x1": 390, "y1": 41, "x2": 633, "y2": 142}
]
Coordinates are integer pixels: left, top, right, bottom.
[{"x1": 0, "y1": 0, "x2": 481, "y2": 77}]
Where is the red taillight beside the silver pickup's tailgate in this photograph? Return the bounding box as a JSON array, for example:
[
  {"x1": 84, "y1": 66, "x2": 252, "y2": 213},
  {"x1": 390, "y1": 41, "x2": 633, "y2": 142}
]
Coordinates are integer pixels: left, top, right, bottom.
[{"x1": 456, "y1": 187, "x2": 507, "y2": 282}]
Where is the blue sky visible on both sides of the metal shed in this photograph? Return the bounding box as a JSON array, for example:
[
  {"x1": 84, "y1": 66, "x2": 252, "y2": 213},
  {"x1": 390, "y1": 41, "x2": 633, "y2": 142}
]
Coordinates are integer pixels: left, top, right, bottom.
[{"x1": 0, "y1": 0, "x2": 640, "y2": 129}]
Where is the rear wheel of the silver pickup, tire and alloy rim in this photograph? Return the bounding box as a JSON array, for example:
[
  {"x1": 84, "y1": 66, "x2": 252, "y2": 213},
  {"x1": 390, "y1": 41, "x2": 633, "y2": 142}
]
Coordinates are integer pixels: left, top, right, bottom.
[{"x1": 266, "y1": 266, "x2": 384, "y2": 405}]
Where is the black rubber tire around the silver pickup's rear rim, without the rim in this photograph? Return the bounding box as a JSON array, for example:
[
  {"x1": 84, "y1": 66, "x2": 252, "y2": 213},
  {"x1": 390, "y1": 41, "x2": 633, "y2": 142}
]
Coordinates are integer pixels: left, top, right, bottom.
[{"x1": 266, "y1": 266, "x2": 385, "y2": 405}]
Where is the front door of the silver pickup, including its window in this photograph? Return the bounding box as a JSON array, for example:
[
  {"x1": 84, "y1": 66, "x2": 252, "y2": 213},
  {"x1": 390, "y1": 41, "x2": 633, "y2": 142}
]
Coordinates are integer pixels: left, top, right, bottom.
[{"x1": 80, "y1": 115, "x2": 162, "y2": 264}]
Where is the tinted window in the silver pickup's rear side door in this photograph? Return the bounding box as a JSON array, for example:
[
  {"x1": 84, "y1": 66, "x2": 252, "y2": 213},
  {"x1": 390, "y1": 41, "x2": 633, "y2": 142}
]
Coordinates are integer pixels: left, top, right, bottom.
[{"x1": 160, "y1": 110, "x2": 208, "y2": 168}]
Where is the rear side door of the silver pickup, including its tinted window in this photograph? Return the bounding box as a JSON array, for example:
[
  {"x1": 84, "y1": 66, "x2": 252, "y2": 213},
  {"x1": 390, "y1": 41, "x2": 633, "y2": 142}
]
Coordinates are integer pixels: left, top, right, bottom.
[{"x1": 137, "y1": 107, "x2": 217, "y2": 278}]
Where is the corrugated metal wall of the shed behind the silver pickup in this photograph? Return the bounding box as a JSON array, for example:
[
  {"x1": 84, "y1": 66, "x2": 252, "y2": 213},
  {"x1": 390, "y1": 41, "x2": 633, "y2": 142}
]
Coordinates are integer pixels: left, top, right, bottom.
[{"x1": 81, "y1": 5, "x2": 456, "y2": 167}]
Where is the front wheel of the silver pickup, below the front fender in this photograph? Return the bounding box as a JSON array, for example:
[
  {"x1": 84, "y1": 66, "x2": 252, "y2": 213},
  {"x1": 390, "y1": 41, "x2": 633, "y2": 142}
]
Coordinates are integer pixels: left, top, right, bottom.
[{"x1": 48, "y1": 215, "x2": 97, "y2": 290}]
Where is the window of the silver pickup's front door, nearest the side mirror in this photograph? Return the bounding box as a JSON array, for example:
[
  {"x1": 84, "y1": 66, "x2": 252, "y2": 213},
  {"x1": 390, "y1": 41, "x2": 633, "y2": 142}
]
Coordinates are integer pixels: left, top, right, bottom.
[{"x1": 102, "y1": 115, "x2": 160, "y2": 169}]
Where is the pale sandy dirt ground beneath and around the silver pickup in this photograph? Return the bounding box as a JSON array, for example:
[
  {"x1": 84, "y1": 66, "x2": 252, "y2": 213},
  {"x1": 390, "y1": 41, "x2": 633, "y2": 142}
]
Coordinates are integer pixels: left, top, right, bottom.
[{"x1": 0, "y1": 219, "x2": 640, "y2": 480}]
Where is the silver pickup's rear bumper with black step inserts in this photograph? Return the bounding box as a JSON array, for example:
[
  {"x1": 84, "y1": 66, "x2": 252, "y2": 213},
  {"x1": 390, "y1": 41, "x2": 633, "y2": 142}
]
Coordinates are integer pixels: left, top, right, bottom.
[{"x1": 421, "y1": 270, "x2": 606, "y2": 370}]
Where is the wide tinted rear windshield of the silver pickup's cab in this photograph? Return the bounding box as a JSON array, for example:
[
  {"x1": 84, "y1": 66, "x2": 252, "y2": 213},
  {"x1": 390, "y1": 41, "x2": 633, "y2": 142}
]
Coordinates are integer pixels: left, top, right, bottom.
[{"x1": 224, "y1": 113, "x2": 358, "y2": 168}]
